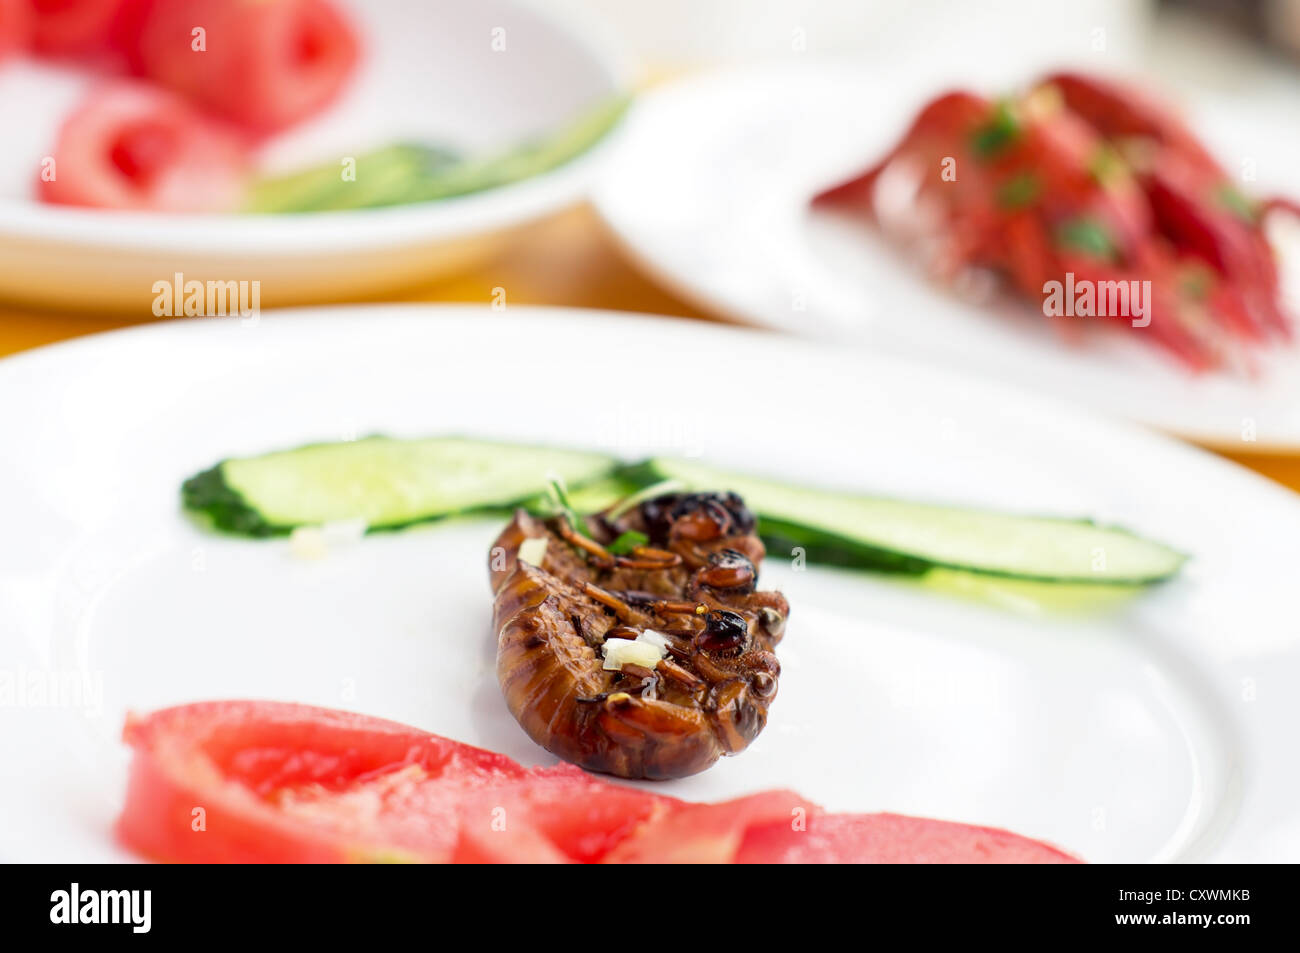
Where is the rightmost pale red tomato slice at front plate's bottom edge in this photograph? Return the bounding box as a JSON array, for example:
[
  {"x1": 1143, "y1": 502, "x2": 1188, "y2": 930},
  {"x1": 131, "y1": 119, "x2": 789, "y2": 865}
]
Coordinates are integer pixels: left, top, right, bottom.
[{"x1": 736, "y1": 814, "x2": 1079, "y2": 863}]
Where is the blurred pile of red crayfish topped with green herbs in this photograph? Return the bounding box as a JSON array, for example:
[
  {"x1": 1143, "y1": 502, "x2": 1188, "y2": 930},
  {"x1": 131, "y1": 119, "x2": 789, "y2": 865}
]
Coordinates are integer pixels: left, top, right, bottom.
[{"x1": 815, "y1": 73, "x2": 1292, "y2": 369}]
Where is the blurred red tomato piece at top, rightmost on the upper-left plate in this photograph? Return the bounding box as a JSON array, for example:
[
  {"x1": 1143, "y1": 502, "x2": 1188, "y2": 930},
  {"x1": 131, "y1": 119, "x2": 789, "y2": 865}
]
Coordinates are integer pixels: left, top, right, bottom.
[{"x1": 128, "y1": 0, "x2": 359, "y2": 134}]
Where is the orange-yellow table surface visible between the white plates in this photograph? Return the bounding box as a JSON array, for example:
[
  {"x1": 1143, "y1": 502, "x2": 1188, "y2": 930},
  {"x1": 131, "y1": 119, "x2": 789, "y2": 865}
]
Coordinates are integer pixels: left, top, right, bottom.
[{"x1": 0, "y1": 208, "x2": 1300, "y2": 490}]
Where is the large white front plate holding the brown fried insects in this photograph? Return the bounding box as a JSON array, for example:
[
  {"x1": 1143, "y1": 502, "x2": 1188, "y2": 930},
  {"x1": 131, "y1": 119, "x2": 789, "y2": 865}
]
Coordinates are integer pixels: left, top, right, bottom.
[{"x1": 0, "y1": 307, "x2": 1300, "y2": 861}]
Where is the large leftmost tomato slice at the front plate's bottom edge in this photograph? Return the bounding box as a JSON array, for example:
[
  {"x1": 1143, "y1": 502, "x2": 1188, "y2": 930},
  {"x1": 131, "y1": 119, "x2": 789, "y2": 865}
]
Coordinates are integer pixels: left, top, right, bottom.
[{"x1": 118, "y1": 702, "x2": 671, "y2": 863}]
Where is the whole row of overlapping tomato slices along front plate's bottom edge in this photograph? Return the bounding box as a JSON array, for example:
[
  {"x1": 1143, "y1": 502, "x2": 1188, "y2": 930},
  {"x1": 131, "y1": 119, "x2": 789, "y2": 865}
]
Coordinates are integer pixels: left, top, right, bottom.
[{"x1": 117, "y1": 701, "x2": 1074, "y2": 863}]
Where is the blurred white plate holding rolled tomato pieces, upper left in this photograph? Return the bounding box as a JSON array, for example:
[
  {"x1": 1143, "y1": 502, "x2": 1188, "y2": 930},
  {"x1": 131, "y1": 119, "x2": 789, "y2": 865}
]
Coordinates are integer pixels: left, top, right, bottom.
[{"x1": 0, "y1": 0, "x2": 627, "y2": 313}]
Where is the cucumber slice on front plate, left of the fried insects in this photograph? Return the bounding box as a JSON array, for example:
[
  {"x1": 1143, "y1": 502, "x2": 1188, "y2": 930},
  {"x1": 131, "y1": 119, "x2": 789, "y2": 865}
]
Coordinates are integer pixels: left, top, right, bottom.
[{"x1": 181, "y1": 437, "x2": 615, "y2": 536}]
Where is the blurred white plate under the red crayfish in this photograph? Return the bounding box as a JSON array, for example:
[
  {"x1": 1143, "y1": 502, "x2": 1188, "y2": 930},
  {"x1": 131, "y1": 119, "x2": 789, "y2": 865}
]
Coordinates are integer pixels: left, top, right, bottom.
[{"x1": 595, "y1": 64, "x2": 1300, "y2": 450}]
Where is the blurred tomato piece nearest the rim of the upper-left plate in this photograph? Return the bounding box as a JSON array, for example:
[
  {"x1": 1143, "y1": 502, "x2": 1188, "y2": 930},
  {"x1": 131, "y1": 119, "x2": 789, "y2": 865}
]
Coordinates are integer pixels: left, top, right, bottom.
[{"x1": 38, "y1": 81, "x2": 247, "y2": 212}]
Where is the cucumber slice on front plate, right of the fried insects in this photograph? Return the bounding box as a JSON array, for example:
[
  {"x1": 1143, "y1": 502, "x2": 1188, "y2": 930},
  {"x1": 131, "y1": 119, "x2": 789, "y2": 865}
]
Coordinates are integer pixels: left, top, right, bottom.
[{"x1": 624, "y1": 459, "x2": 1187, "y2": 585}]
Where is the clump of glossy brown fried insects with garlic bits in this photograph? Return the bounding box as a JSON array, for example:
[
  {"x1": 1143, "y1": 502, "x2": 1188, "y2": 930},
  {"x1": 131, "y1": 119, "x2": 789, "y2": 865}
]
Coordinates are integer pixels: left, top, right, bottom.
[{"x1": 490, "y1": 493, "x2": 789, "y2": 779}]
